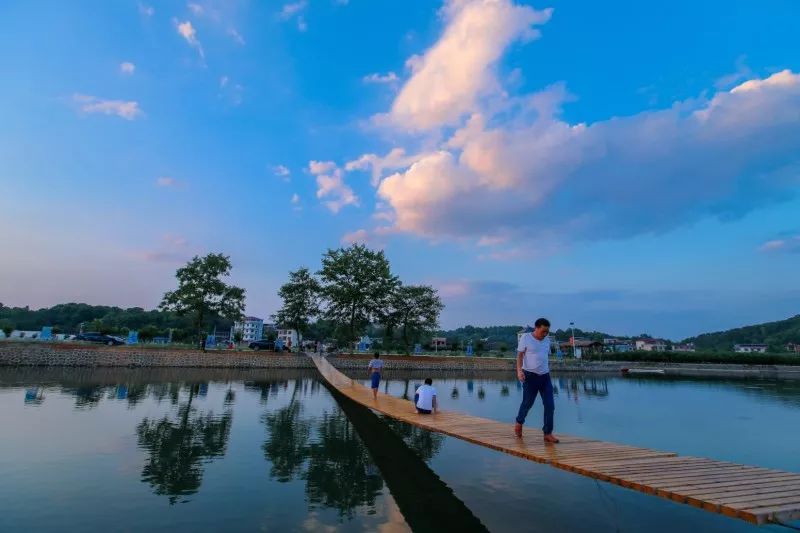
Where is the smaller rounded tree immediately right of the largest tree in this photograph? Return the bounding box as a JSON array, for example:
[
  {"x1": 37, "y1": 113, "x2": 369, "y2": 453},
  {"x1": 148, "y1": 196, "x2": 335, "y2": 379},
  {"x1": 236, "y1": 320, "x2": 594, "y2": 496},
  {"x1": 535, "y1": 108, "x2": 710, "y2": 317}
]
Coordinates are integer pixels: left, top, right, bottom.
[{"x1": 391, "y1": 285, "x2": 444, "y2": 353}]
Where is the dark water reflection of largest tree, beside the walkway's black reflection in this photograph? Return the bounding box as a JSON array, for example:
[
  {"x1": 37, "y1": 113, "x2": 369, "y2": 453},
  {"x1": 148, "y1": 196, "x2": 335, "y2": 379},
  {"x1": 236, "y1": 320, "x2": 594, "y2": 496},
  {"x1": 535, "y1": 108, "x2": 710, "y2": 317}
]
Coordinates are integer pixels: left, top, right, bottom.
[{"x1": 305, "y1": 407, "x2": 383, "y2": 518}]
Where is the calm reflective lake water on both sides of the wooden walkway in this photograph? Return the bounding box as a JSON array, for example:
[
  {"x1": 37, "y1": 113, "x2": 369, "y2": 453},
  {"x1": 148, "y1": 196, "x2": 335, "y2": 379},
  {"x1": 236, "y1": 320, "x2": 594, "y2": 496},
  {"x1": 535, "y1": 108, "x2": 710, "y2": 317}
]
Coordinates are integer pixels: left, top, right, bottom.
[{"x1": 0, "y1": 369, "x2": 800, "y2": 532}]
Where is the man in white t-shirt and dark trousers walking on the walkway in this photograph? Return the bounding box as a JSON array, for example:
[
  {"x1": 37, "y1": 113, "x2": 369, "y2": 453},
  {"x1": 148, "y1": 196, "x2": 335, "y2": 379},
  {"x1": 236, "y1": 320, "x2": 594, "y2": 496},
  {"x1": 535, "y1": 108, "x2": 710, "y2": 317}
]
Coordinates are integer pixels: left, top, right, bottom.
[{"x1": 514, "y1": 318, "x2": 558, "y2": 443}]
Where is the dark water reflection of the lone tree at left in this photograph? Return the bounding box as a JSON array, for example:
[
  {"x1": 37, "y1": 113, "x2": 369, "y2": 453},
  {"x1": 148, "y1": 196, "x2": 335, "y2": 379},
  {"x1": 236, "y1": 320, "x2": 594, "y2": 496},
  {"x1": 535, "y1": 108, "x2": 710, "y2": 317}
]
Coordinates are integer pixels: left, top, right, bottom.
[{"x1": 136, "y1": 385, "x2": 233, "y2": 504}]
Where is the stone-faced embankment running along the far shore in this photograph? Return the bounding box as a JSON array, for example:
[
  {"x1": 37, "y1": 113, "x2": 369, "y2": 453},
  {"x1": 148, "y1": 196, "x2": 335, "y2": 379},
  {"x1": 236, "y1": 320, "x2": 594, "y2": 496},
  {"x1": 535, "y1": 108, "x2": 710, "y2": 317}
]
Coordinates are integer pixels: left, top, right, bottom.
[{"x1": 0, "y1": 342, "x2": 800, "y2": 379}]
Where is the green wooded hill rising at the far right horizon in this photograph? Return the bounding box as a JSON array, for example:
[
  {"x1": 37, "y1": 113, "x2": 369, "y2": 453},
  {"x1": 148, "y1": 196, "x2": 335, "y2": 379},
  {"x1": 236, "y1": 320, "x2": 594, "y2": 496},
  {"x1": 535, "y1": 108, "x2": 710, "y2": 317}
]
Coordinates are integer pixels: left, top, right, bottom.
[{"x1": 684, "y1": 315, "x2": 800, "y2": 352}]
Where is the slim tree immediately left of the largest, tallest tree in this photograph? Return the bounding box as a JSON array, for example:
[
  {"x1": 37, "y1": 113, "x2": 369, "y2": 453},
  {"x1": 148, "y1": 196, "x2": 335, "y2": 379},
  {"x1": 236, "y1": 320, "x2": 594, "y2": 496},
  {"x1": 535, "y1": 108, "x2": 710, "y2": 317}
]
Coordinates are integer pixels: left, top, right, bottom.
[{"x1": 275, "y1": 267, "x2": 320, "y2": 350}]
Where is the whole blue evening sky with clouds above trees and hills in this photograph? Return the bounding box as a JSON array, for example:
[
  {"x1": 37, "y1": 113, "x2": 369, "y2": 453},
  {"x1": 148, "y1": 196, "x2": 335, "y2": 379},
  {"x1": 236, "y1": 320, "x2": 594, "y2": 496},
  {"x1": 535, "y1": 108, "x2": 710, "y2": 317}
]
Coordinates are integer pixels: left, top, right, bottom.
[{"x1": 0, "y1": 0, "x2": 800, "y2": 338}]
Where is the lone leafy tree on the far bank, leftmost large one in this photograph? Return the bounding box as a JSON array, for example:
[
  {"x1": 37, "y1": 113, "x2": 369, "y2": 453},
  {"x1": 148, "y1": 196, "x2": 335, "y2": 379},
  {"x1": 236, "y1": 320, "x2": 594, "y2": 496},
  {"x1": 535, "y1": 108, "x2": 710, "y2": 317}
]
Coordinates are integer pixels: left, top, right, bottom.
[{"x1": 159, "y1": 253, "x2": 244, "y2": 349}]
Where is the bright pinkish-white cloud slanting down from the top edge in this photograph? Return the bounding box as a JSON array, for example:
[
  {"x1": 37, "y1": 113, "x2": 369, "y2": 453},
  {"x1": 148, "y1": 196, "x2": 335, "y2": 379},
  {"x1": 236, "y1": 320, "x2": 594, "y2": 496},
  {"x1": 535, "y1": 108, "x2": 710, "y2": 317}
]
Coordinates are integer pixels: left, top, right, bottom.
[{"x1": 385, "y1": 0, "x2": 552, "y2": 130}]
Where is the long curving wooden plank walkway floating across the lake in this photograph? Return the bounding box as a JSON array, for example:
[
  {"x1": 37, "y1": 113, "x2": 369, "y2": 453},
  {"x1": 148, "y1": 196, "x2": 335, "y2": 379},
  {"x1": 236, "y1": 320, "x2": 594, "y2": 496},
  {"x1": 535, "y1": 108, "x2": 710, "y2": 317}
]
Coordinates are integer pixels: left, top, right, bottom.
[{"x1": 310, "y1": 355, "x2": 800, "y2": 525}]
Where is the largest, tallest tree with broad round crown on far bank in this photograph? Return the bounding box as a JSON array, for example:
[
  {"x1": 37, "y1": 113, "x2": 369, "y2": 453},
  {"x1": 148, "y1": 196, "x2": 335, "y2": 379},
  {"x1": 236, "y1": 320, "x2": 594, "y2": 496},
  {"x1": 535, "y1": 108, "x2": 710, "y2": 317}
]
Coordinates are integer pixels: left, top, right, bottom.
[{"x1": 319, "y1": 244, "x2": 398, "y2": 341}]
